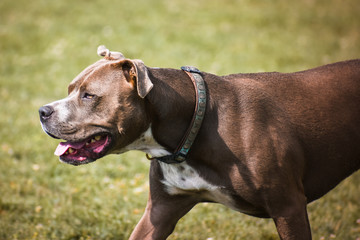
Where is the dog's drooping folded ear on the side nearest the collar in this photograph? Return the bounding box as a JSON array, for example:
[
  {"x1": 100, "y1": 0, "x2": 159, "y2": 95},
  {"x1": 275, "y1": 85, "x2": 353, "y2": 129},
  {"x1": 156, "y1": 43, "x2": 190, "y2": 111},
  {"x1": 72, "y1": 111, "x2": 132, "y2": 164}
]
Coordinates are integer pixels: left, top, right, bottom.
[{"x1": 121, "y1": 59, "x2": 154, "y2": 98}]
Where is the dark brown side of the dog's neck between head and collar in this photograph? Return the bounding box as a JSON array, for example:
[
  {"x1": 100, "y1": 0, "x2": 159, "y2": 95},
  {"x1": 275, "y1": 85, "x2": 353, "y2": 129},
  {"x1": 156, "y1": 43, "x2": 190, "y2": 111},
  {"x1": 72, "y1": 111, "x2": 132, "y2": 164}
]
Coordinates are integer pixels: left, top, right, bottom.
[{"x1": 146, "y1": 68, "x2": 196, "y2": 152}]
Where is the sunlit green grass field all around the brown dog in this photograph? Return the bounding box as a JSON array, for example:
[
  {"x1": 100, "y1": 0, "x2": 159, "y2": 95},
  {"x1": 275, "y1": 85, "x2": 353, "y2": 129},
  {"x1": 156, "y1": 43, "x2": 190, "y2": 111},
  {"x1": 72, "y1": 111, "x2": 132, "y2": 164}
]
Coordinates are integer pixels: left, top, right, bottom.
[{"x1": 0, "y1": 0, "x2": 360, "y2": 240}]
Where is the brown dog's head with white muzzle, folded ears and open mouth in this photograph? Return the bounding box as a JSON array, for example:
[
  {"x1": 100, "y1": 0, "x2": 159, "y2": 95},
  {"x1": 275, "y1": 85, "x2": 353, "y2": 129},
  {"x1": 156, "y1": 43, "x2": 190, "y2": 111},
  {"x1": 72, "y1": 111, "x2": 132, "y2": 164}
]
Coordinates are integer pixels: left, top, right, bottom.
[{"x1": 39, "y1": 46, "x2": 153, "y2": 165}]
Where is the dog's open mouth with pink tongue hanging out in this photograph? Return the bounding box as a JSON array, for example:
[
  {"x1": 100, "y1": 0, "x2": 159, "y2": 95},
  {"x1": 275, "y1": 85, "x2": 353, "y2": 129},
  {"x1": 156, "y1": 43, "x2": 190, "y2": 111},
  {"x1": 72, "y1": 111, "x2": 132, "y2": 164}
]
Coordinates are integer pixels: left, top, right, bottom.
[{"x1": 54, "y1": 134, "x2": 111, "y2": 165}]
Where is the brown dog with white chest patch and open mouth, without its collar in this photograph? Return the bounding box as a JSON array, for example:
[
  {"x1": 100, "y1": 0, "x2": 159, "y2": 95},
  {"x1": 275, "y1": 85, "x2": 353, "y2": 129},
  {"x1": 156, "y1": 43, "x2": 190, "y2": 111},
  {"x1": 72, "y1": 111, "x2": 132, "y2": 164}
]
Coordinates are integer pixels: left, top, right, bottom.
[{"x1": 39, "y1": 46, "x2": 360, "y2": 240}]
